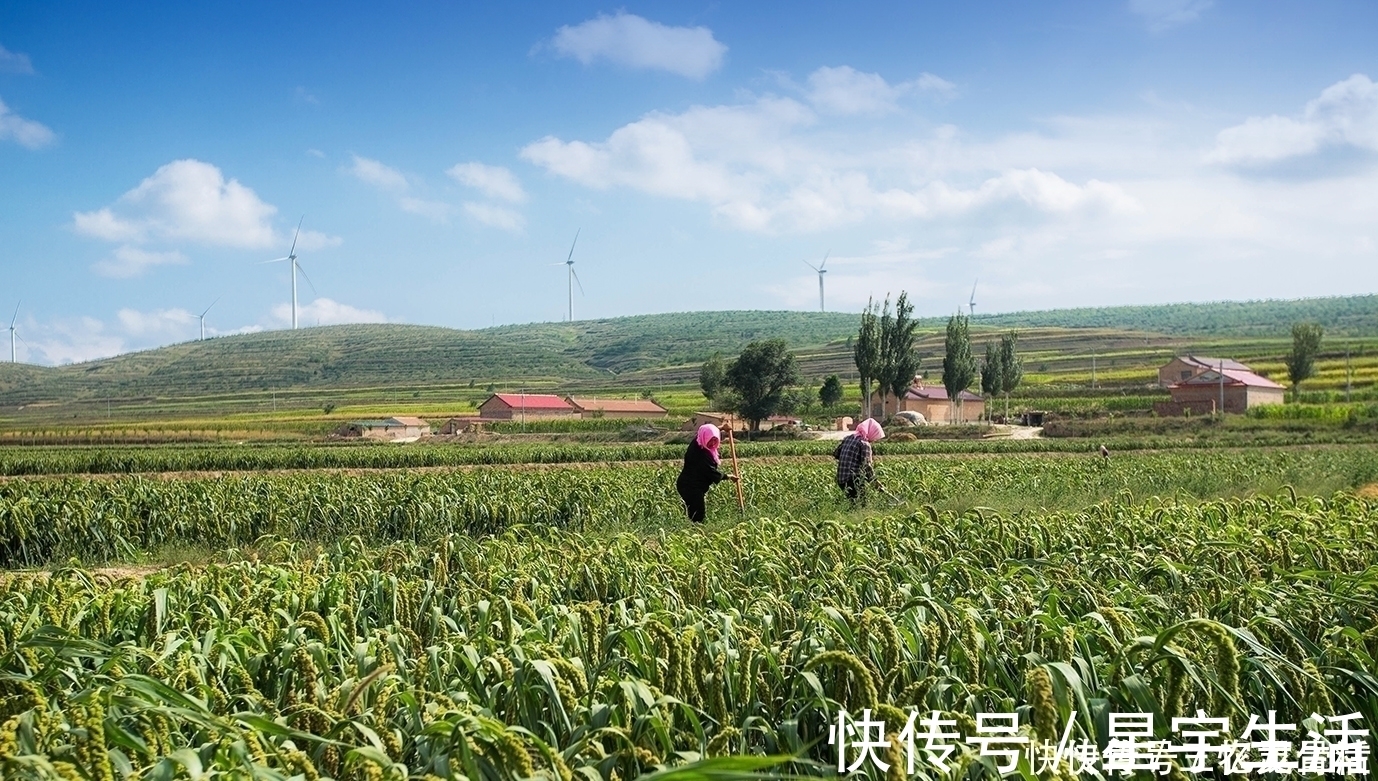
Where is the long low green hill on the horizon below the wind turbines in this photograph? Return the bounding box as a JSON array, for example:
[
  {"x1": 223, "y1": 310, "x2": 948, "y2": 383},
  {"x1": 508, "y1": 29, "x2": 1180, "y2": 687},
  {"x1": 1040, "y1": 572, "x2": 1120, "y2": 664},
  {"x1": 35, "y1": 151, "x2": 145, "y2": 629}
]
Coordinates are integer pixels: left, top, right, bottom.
[{"x1": 0, "y1": 296, "x2": 1378, "y2": 406}]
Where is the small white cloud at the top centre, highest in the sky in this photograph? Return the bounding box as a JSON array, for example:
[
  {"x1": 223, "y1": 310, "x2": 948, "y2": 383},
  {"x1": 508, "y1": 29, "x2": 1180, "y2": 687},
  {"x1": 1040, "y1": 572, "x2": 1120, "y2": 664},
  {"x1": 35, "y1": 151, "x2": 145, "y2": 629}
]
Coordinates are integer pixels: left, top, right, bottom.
[{"x1": 553, "y1": 11, "x2": 728, "y2": 79}]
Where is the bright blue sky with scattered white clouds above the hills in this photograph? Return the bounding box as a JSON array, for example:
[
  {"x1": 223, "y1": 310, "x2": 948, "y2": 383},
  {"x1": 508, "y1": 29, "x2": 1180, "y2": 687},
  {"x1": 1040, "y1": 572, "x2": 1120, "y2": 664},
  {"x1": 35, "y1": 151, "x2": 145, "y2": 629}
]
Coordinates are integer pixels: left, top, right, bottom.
[{"x1": 0, "y1": 0, "x2": 1378, "y2": 364}]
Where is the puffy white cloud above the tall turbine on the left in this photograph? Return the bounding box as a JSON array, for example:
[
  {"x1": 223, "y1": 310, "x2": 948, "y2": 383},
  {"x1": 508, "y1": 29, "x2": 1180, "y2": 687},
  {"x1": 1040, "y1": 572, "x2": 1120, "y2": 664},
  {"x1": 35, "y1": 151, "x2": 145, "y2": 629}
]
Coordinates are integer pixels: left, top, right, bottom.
[{"x1": 73, "y1": 160, "x2": 327, "y2": 249}]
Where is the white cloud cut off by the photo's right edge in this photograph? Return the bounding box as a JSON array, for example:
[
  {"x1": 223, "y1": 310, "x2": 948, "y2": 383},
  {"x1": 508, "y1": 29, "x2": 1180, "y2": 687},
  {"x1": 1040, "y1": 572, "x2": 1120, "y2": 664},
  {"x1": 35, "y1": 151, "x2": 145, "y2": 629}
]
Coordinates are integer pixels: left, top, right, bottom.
[{"x1": 1206, "y1": 73, "x2": 1378, "y2": 165}]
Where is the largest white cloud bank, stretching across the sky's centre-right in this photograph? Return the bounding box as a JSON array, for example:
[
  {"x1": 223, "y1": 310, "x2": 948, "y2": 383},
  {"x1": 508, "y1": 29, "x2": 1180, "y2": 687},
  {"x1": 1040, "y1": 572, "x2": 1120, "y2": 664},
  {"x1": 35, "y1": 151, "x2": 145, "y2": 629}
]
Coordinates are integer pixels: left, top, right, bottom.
[{"x1": 521, "y1": 98, "x2": 1135, "y2": 233}]
